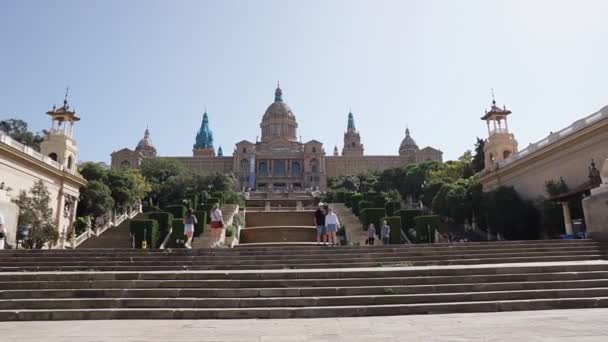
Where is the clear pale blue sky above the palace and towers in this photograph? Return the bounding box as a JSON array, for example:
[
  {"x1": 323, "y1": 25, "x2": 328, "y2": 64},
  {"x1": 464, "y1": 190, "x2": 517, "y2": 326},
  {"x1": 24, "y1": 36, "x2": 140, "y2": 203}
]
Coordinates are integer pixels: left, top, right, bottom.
[{"x1": 0, "y1": 0, "x2": 608, "y2": 162}]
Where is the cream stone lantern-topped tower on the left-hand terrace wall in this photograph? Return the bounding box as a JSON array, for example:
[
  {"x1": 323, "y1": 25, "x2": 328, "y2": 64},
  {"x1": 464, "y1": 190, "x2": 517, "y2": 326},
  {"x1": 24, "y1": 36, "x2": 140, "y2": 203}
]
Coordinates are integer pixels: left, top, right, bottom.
[{"x1": 40, "y1": 88, "x2": 80, "y2": 173}]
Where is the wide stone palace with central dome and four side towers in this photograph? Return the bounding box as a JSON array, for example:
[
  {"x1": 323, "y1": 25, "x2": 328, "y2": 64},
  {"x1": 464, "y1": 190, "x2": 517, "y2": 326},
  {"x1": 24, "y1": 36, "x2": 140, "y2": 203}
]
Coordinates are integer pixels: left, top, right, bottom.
[{"x1": 112, "y1": 86, "x2": 442, "y2": 190}]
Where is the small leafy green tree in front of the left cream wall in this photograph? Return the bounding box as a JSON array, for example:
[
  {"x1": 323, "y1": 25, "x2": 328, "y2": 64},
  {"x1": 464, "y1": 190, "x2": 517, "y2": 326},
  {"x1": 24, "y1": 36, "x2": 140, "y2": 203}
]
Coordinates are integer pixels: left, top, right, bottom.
[{"x1": 13, "y1": 180, "x2": 59, "y2": 249}]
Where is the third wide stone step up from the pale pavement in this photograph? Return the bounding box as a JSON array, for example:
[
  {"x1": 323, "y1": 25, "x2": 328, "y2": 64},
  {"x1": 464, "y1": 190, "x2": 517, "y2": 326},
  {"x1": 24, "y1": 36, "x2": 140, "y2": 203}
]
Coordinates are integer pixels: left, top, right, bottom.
[{"x1": 0, "y1": 279, "x2": 608, "y2": 299}]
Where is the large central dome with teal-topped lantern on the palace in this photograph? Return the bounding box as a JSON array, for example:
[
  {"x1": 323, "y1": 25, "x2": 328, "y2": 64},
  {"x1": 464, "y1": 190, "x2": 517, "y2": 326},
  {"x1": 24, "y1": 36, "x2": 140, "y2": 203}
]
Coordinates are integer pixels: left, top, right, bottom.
[{"x1": 260, "y1": 87, "x2": 298, "y2": 142}]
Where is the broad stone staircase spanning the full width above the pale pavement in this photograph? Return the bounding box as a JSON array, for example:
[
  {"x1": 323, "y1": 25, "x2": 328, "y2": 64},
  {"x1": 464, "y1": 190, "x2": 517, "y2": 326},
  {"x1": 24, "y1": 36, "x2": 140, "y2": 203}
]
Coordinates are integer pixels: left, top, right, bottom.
[{"x1": 0, "y1": 240, "x2": 608, "y2": 320}]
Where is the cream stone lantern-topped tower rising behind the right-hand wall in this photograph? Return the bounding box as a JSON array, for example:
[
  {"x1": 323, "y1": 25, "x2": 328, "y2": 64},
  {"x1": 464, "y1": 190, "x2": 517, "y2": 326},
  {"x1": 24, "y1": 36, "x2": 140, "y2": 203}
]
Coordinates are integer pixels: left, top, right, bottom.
[{"x1": 481, "y1": 93, "x2": 517, "y2": 171}]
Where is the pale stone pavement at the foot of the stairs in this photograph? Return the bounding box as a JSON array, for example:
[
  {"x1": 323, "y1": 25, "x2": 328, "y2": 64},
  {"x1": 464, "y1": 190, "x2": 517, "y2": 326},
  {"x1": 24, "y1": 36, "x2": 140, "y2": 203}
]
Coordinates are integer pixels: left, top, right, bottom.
[{"x1": 0, "y1": 309, "x2": 608, "y2": 342}]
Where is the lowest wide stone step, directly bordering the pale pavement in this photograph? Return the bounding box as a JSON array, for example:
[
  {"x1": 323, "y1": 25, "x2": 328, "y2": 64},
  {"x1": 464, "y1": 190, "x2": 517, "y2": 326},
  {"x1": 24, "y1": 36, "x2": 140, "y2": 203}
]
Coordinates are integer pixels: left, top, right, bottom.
[{"x1": 0, "y1": 297, "x2": 608, "y2": 321}]
